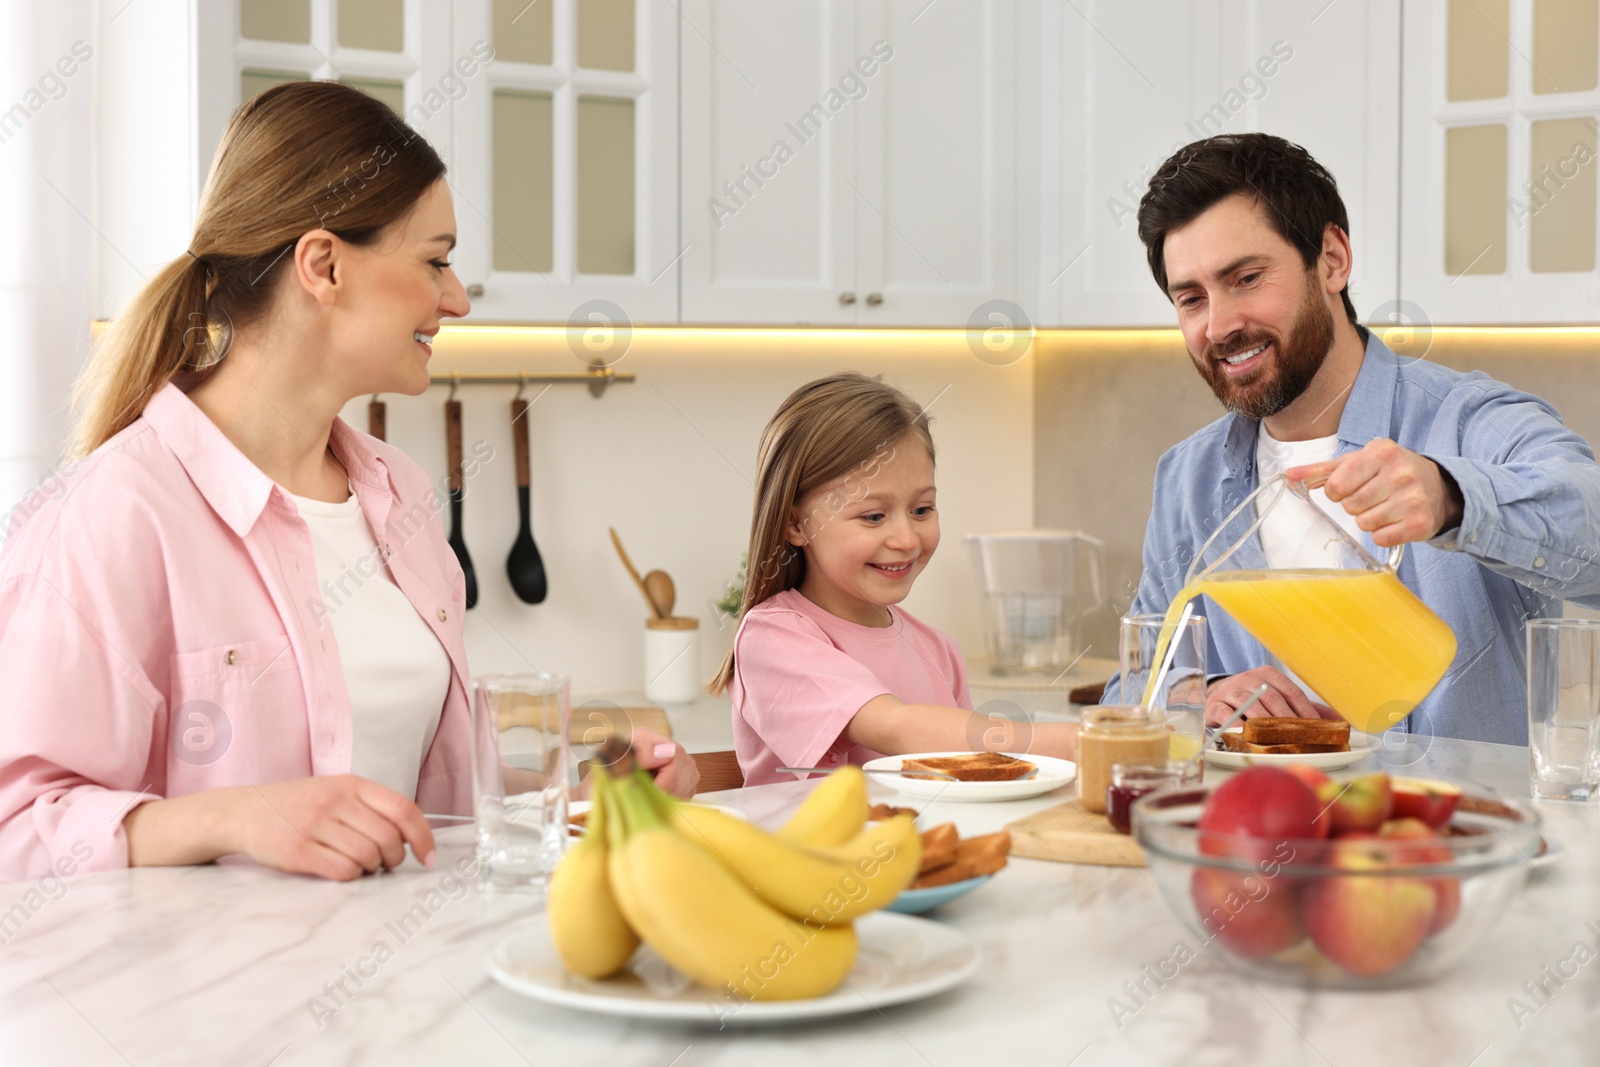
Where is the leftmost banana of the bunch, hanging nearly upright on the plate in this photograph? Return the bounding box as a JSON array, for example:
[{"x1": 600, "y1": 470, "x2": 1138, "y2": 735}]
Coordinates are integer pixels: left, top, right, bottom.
[{"x1": 547, "y1": 773, "x2": 638, "y2": 977}]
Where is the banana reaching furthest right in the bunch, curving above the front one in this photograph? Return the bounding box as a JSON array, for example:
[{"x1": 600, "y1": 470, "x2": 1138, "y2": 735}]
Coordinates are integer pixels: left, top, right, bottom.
[{"x1": 670, "y1": 805, "x2": 922, "y2": 923}]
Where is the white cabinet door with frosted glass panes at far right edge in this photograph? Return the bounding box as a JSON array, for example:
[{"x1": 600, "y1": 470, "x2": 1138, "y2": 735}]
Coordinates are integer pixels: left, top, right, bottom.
[{"x1": 1400, "y1": 0, "x2": 1600, "y2": 323}]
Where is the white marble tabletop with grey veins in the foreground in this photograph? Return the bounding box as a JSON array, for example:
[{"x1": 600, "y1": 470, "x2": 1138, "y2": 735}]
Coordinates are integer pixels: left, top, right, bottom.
[{"x1": 0, "y1": 741, "x2": 1600, "y2": 1067}]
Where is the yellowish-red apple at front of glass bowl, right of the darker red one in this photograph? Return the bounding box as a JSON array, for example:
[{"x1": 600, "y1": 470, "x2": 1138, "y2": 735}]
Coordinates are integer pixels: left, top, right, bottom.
[{"x1": 1301, "y1": 833, "x2": 1437, "y2": 977}]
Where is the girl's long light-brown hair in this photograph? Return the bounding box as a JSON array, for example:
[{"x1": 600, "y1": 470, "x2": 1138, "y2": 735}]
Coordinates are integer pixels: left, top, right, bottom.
[{"x1": 706, "y1": 371, "x2": 933, "y2": 693}]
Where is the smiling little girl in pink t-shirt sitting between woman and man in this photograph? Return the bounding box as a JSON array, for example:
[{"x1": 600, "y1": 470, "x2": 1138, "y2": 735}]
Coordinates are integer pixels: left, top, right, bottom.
[{"x1": 710, "y1": 373, "x2": 1077, "y2": 785}]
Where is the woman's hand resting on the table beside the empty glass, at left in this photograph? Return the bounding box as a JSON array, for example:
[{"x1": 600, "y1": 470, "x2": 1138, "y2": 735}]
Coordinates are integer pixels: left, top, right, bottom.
[{"x1": 123, "y1": 774, "x2": 434, "y2": 881}]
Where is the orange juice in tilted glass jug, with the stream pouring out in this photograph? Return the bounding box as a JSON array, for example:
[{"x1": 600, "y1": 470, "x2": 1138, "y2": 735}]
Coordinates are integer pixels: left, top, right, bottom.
[{"x1": 1144, "y1": 569, "x2": 1456, "y2": 734}]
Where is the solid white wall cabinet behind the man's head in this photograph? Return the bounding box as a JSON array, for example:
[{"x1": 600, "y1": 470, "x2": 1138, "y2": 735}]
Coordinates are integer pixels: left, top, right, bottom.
[{"x1": 1026, "y1": 0, "x2": 1400, "y2": 326}]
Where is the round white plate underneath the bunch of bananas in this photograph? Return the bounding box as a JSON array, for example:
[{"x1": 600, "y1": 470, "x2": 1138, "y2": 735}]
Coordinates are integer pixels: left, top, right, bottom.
[{"x1": 485, "y1": 912, "x2": 978, "y2": 1025}]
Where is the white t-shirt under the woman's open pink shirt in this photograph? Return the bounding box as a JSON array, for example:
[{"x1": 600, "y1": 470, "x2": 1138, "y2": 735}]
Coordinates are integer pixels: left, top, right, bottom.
[{"x1": 290, "y1": 493, "x2": 450, "y2": 798}]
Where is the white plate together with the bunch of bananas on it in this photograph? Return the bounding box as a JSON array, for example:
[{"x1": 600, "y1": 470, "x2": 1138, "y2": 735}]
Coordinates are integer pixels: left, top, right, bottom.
[{"x1": 512, "y1": 764, "x2": 978, "y2": 1025}]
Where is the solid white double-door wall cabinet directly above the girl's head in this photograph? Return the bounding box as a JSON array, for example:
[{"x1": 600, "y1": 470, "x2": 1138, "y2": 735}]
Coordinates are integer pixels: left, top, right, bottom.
[{"x1": 682, "y1": 0, "x2": 1016, "y2": 326}]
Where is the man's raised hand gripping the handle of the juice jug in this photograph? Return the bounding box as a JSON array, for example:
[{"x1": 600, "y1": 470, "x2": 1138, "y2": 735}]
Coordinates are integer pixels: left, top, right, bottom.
[{"x1": 1283, "y1": 437, "x2": 1462, "y2": 549}]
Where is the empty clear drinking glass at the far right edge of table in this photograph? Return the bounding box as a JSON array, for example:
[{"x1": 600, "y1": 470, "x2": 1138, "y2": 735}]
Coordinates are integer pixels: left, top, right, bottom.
[{"x1": 1528, "y1": 619, "x2": 1600, "y2": 800}]
